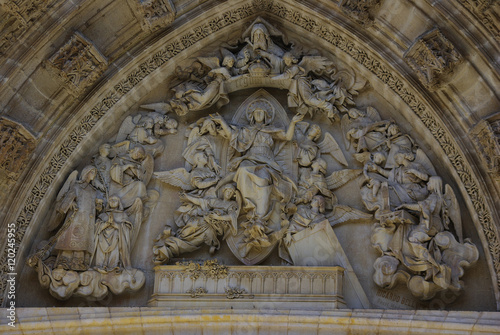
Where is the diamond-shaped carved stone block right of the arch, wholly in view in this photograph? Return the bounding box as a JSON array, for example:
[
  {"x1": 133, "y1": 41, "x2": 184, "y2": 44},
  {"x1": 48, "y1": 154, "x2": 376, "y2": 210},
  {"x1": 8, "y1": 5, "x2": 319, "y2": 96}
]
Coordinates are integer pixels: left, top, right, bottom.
[{"x1": 403, "y1": 28, "x2": 463, "y2": 90}]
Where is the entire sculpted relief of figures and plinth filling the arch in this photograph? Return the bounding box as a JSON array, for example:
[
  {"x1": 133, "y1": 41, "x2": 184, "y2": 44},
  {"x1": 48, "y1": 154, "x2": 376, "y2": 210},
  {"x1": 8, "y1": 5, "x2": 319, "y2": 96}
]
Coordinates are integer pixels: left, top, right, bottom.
[{"x1": 28, "y1": 18, "x2": 486, "y2": 309}]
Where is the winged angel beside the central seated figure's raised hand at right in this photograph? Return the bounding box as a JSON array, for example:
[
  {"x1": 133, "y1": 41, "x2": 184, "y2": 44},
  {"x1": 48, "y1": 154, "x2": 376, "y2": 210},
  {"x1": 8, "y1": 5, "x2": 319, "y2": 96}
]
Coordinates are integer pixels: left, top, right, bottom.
[{"x1": 295, "y1": 122, "x2": 347, "y2": 167}]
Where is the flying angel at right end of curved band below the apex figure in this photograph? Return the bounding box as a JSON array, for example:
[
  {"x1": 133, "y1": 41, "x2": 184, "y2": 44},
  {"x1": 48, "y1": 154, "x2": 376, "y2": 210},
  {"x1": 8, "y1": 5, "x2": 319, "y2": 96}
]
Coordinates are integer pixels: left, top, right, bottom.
[{"x1": 273, "y1": 53, "x2": 340, "y2": 121}]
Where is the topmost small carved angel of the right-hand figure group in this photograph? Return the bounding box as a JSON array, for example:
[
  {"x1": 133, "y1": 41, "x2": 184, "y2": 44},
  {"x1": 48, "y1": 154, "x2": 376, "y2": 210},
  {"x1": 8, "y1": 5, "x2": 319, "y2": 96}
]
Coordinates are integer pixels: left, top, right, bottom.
[{"x1": 341, "y1": 107, "x2": 389, "y2": 153}]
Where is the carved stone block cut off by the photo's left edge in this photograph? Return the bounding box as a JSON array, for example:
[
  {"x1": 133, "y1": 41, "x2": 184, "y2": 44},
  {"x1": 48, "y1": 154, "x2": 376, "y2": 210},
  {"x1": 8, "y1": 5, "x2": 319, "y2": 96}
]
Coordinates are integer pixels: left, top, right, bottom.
[{"x1": 0, "y1": 118, "x2": 35, "y2": 180}]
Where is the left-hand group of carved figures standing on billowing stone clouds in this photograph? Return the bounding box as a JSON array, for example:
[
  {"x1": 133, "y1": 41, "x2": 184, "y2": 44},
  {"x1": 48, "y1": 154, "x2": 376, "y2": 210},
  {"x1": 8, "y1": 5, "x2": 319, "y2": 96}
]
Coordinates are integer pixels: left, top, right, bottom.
[{"x1": 28, "y1": 112, "x2": 177, "y2": 300}]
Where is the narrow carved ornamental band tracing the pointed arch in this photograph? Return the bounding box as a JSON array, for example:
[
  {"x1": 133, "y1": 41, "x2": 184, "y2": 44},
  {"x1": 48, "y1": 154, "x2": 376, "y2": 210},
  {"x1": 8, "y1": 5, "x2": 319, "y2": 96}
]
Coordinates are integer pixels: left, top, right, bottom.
[{"x1": 0, "y1": 0, "x2": 500, "y2": 304}]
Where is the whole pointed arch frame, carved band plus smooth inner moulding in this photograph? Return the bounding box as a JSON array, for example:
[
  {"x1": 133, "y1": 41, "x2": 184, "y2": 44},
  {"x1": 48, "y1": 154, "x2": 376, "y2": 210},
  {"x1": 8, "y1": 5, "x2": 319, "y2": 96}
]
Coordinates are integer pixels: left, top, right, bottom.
[{"x1": 3, "y1": 1, "x2": 500, "y2": 312}]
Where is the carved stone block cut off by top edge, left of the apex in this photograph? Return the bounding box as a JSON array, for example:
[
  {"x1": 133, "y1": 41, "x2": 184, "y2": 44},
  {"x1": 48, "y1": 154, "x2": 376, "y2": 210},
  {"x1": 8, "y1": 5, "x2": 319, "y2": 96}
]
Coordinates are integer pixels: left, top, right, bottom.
[{"x1": 128, "y1": 0, "x2": 175, "y2": 31}]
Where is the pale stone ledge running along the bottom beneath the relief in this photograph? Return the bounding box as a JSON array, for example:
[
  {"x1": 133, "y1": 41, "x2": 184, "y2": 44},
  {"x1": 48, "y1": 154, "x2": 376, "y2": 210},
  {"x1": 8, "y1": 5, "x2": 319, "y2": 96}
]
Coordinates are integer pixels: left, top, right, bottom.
[{"x1": 0, "y1": 307, "x2": 500, "y2": 335}]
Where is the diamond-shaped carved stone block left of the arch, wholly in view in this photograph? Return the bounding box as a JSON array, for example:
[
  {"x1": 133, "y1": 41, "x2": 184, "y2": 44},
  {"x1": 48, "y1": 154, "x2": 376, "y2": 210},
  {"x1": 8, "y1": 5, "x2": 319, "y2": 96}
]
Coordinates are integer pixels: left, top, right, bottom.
[{"x1": 46, "y1": 32, "x2": 108, "y2": 96}]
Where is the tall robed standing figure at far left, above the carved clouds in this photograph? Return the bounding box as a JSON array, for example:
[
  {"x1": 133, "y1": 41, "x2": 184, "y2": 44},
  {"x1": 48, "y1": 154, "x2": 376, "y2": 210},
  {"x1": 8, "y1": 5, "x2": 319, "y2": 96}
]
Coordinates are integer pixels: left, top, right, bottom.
[{"x1": 48, "y1": 166, "x2": 97, "y2": 271}]
